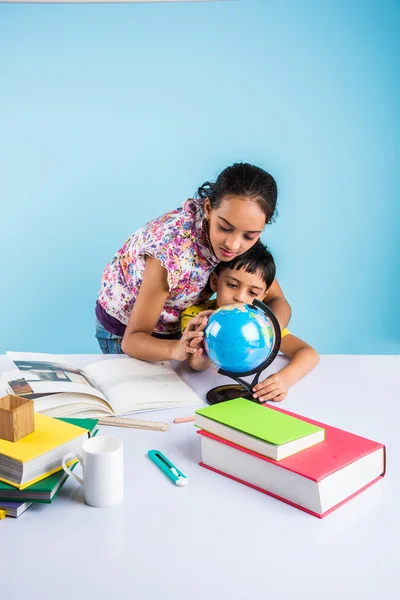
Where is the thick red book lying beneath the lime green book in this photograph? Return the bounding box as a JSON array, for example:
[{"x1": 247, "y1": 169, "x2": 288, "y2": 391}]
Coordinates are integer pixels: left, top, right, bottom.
[{"x1": 198, "y1": 406, "x2": 386, "y2": 518}]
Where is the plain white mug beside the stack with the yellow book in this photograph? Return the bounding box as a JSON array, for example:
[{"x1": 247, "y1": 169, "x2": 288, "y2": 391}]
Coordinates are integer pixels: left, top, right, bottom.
[{"x1": 62, "y1": 435, "x2": 124, "y2": 508}]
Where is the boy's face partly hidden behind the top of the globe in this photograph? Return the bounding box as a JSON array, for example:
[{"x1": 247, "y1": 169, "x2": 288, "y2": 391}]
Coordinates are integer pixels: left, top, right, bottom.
[{"x1": 210, "y1": 269, "x2": 267, "y2": 307}]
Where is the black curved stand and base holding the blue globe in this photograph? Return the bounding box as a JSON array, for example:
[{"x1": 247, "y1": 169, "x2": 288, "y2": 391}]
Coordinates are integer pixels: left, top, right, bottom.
[{"x1": 206, "y1": 300, "x2": 281, "y2": 404}]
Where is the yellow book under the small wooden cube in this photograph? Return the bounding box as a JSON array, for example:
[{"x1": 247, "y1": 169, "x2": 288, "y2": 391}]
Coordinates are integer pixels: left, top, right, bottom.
[{"x1": 0, "y1": 413, "x2": 89, "y2": 490}]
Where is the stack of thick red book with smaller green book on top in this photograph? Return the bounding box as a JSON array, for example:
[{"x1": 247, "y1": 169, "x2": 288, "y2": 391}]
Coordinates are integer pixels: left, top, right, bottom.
[{"x1": 195, "y1": 398, "x2": 386, "y2": 518}]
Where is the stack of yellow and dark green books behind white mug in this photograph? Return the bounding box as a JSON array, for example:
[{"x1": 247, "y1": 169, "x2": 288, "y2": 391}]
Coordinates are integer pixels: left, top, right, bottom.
[{"x1": 0, "y1": 413, "x2": 98, "y2": 517}]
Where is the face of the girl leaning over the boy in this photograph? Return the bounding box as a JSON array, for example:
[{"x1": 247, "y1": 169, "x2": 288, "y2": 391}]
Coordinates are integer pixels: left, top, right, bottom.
[{"x1": 204, "y1": 196, "x2": 265, "y2": 262}]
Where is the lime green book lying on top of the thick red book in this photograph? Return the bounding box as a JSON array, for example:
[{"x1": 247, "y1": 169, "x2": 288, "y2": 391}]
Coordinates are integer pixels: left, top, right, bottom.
[{"x1": 194, "y1": 398, "x2": 325, "y2": 460}]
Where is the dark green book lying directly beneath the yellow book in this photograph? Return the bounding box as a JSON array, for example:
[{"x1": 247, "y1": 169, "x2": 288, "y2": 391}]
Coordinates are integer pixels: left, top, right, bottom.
[{"x1": 0, "y1": 418, "x2": 98, "y2": 503}]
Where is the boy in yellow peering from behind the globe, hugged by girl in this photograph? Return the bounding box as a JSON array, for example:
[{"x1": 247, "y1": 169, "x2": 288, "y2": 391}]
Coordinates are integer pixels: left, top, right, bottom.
[{"x1": 181, "y1": 242, "x2": 319, "y2": 402}]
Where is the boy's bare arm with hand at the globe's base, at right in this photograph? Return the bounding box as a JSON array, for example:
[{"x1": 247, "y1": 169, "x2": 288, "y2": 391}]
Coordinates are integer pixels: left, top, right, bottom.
[{"x1": 253, "y1": 333, "x2": 319, "y2": 402}]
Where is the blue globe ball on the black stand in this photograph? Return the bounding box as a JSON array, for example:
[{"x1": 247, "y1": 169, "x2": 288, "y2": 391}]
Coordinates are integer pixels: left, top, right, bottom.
[{"x1": 204, "y1": 304, "x2": 275, "y2": 373}]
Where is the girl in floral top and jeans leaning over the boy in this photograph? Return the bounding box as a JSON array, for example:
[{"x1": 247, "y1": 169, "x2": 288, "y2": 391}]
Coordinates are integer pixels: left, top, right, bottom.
[{"x1": 96, "y1": 163, "x2": 291, "y2": 361}]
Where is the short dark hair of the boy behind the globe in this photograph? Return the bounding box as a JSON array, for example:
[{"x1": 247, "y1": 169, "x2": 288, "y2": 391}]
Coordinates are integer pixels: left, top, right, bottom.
[{"x1": 215, "y1": 241, "x2": 276, "y2": 289}]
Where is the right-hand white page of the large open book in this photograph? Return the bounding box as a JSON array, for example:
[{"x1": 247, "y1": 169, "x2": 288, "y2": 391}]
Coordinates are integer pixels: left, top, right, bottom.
[{"x1": 85, "y1": 357, "x2": 203, "y2": 416}]
